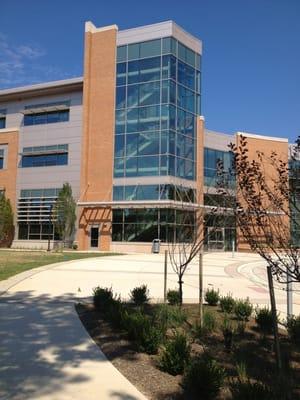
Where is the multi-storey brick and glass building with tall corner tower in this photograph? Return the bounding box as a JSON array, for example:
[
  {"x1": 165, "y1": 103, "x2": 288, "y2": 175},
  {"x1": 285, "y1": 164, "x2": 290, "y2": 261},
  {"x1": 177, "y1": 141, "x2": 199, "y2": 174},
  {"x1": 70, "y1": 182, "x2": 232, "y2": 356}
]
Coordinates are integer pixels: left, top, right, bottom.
[{"x1": 0, "y1": 21, "x2": 288, "y2": 251}]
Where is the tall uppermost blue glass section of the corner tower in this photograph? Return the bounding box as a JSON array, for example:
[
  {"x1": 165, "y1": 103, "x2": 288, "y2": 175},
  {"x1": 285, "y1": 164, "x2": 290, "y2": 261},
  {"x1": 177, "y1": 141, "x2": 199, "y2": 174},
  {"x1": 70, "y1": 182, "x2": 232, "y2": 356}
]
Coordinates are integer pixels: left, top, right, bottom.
[{"x1": 114, "y1": 38, "x2": 200, "y2": 180}]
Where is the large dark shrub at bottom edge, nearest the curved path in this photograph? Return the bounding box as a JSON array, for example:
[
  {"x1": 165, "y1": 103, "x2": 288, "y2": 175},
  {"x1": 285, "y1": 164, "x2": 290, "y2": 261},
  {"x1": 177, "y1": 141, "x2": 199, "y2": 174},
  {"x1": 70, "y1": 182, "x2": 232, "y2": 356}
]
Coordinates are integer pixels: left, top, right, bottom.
[{"x1": 183, "y1": 353, "x2": 225, "y2": 400}]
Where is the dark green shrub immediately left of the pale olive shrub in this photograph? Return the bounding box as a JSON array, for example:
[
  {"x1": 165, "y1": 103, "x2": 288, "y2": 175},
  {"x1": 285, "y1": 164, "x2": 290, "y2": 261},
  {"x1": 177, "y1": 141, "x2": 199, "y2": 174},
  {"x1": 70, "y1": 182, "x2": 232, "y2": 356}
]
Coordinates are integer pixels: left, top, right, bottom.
[{"x1": 124, "y1": 311, "x2": 163, "y2": 354}]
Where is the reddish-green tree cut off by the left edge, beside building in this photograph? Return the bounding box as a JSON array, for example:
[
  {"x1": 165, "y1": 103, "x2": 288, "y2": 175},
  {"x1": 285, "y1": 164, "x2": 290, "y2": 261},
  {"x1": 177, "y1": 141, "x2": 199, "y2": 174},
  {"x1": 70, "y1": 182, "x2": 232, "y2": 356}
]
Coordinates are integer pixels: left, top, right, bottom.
[{"x1": 0, "y1": 194, "x2": 14, "y2": 247}]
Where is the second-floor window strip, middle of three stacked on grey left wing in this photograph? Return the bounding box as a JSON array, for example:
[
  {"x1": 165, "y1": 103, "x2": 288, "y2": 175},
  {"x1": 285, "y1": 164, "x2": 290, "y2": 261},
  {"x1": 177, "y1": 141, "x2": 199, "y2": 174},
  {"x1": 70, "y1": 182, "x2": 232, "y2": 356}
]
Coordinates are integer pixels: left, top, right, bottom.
[{"x1": 22, "y1": 144, "x2": 68, "y2": 168}]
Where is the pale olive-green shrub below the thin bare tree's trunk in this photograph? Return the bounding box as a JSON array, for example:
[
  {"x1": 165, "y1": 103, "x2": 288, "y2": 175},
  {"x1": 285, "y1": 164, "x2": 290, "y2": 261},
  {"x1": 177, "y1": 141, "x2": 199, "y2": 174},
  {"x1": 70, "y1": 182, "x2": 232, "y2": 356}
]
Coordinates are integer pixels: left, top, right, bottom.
[{"x1": 154, "y1": 304, "x2": 187, "y2": 332}]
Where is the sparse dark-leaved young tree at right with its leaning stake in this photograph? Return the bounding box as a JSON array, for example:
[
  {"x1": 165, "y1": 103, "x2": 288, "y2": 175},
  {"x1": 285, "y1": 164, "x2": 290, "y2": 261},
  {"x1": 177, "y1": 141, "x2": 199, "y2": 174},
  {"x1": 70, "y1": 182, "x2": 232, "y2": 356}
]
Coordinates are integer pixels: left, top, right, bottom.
[{"x1": 219, "y1": 136, "x2": 300, "y2": 370}]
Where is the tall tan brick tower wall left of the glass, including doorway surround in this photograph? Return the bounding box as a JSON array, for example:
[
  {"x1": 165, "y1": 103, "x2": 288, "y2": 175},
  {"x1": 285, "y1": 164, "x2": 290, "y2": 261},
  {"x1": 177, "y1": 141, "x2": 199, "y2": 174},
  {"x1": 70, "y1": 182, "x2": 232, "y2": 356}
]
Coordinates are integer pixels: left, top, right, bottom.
[{"x1": 77, "y1": 27, "x2": 117, "y2": 250}]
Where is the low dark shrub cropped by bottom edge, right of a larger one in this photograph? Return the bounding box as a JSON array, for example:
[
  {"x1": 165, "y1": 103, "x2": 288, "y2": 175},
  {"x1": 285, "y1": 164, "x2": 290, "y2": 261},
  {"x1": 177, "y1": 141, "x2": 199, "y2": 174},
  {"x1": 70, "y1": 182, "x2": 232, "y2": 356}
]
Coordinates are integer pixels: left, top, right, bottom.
[{"x1": 230, "y1": 379, "x2": 274, "y2": 400}]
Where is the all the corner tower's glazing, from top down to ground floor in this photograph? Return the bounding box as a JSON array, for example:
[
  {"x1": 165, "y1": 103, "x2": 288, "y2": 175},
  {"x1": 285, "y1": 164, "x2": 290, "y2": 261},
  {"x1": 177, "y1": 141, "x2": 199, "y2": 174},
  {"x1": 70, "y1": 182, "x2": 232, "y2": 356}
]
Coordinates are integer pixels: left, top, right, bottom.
[{"x1": 113, "y1": 37, "x2": 201, "y2": 242}]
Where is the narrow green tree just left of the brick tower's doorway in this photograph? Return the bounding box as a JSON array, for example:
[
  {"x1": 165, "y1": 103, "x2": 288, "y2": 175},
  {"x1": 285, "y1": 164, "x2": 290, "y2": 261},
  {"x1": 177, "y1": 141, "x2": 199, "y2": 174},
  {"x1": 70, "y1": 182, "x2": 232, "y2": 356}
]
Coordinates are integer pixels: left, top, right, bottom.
[{"x1": 52, "y1": 183, "x2": 76, "y2": 242}]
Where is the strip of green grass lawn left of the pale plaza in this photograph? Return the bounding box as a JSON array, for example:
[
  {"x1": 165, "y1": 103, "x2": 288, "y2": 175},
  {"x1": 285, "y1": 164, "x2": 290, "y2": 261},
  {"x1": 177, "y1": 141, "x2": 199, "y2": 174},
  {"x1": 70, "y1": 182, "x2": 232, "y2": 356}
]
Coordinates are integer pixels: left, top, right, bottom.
[{"x1": 0, "y1": 250, "x2": 116, "y2": 281}]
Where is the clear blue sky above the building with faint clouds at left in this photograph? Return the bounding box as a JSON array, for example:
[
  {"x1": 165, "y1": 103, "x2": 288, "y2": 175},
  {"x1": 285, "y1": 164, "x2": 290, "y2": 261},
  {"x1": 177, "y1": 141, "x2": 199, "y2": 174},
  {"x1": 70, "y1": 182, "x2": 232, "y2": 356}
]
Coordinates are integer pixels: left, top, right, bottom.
[{"x1": 0, "y1": 0, "x2": 300, "y2": 142}]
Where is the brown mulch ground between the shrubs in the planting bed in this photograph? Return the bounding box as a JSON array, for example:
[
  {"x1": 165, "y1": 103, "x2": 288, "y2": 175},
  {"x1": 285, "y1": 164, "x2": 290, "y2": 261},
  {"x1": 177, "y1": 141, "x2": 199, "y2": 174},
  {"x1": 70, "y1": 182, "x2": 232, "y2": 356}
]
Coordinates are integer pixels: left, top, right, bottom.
[{"x1": 76, "y1": 304, "x2": 300, "y2": 400}]
